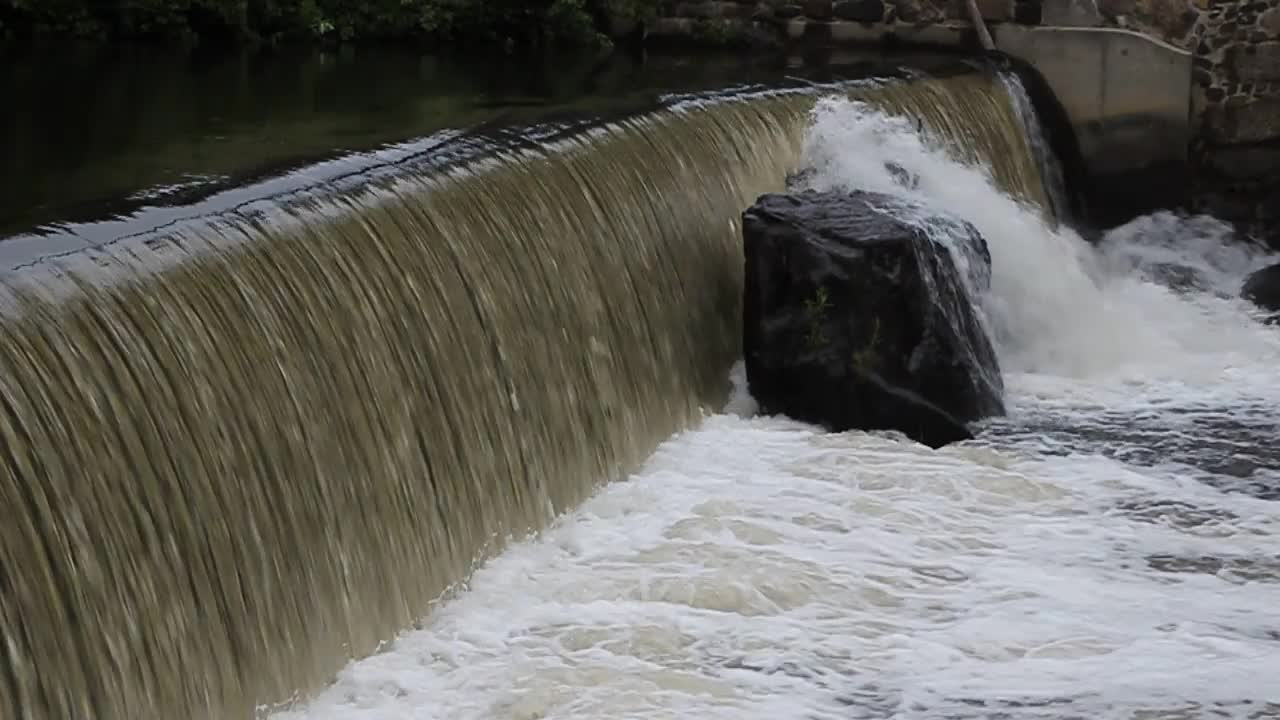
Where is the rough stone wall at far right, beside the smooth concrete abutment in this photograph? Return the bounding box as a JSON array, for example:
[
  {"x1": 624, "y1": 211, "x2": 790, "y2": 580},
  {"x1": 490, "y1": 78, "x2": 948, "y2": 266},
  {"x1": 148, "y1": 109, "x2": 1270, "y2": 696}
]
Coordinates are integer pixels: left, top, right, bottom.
[{"x1": 1192, "y1": 0, "x2": 1280, "y2": 247}]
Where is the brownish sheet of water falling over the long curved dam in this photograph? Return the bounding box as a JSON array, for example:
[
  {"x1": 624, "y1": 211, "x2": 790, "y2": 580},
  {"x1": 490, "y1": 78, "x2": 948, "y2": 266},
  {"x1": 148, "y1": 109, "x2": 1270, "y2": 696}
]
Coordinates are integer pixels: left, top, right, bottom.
[{"x1": 0, "y1": 72, "x2": 1048, "y2": 720}]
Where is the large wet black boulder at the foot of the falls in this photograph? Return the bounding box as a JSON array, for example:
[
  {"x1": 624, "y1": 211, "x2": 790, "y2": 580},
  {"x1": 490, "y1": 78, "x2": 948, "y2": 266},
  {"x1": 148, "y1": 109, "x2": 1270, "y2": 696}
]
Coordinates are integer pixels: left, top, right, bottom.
[{"x1": 742, "y1": 191, "x2": 1004, "y2": 447}]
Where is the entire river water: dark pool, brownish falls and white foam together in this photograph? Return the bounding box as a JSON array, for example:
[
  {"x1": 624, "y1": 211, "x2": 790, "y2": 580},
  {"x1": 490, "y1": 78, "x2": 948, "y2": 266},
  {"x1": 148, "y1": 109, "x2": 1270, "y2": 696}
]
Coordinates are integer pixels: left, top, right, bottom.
[{"x1": 0, "y1": 46, "x2": 1280, "y2": 720}]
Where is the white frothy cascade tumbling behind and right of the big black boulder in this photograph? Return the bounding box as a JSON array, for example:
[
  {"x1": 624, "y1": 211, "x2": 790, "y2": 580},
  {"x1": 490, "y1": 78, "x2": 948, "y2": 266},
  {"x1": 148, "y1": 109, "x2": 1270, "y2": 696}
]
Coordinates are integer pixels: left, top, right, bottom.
[{"x1": 788, "y1": 99, "x2": 1274, "y2": 378}]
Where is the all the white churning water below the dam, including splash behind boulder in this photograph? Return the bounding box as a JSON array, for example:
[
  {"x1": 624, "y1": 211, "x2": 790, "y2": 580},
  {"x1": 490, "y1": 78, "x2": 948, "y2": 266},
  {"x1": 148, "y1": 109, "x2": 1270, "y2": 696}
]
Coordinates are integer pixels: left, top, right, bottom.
[{"x1": 276, "y1": 92, "x2": 1280, "y2": 720}]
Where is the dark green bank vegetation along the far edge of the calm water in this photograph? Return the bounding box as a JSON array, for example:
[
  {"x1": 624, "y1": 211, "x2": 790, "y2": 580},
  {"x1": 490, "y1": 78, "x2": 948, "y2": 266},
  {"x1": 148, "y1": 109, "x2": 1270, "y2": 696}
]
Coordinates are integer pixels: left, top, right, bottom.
[{"x1": 0, "y1": 0, "x2": 658, "y2": 50}]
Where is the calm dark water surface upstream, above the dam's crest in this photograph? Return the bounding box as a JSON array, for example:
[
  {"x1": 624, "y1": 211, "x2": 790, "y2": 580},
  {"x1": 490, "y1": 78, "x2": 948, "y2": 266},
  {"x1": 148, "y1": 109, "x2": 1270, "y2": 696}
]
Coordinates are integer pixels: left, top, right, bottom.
[{"x1": 0, "y1": 49, "x2": 956, "y2": 236}]
